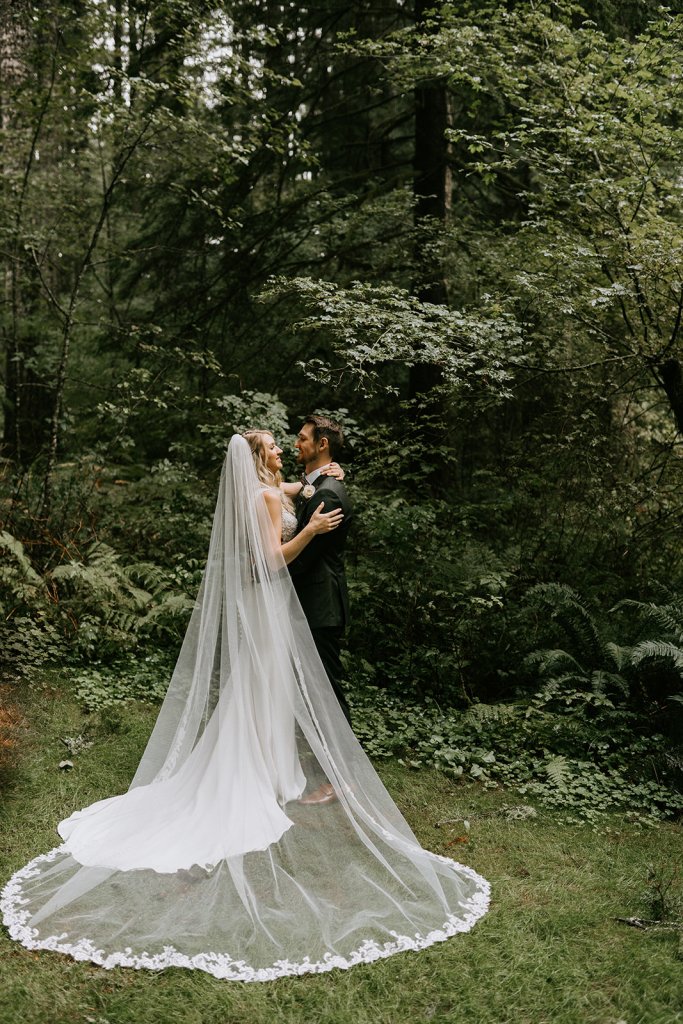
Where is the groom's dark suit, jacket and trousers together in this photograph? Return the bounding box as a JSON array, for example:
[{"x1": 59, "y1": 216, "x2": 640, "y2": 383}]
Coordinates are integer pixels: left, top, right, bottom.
[{"x1": 290, "y1": 476, "x2": 352, "y2": 722}]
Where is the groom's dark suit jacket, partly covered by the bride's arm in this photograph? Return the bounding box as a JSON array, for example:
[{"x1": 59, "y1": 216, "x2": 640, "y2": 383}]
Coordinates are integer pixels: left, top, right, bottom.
[{"x1": 289, "y1": 476, "x2": 352, "y2": 629}]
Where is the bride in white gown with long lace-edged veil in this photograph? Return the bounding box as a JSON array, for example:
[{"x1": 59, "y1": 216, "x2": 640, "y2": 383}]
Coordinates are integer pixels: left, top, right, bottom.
[{"x1": 0, "y1": 431, "x2": 488, "y2": 981}]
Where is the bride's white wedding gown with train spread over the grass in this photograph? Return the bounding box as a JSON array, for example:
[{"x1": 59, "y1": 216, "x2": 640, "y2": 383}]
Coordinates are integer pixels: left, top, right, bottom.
[{"x1": 57, "y1": 520, "x2": 306, "y2": 872}]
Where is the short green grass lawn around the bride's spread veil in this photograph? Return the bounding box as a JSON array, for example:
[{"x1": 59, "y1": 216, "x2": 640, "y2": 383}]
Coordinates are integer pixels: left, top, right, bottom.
[{"x1": 0, "y1": 679, "x2": 683, "y2": 1024}]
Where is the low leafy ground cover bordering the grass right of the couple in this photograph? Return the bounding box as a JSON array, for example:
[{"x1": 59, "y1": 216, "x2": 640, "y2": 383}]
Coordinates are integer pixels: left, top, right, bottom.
[{"x1": 350, "y1": 685, "x2": 683, "y2": 825}]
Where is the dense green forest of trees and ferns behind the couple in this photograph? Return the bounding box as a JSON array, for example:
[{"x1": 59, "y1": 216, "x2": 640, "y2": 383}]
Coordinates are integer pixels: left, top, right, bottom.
[{"x1": 0, "y1": 0, "x2": 683, "y2": 839}]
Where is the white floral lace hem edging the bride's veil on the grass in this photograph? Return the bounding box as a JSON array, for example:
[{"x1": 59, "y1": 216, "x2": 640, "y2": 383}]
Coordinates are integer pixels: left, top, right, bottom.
[{"x1": 0, "y1": 846, "x2": 490, "y2": 981}]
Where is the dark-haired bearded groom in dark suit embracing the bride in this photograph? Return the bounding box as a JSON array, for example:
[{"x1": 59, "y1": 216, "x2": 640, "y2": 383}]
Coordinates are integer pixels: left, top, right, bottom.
[{"x1": 290, "y1": 416, "x2": 352, "y2": 761}]
